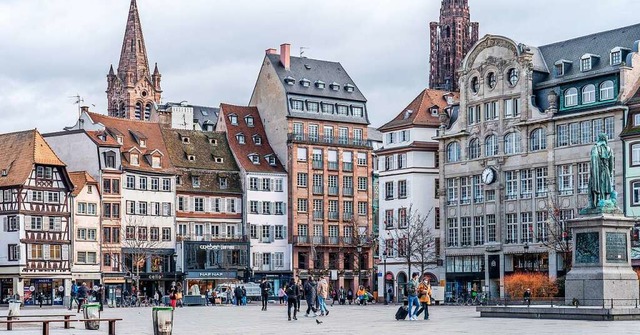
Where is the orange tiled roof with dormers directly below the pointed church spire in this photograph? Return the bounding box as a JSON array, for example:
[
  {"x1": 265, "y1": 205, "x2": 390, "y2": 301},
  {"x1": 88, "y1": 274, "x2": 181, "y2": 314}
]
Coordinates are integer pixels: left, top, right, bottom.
[{"x1": 87, "y1": 112, "x2": 173, "y2": 174}]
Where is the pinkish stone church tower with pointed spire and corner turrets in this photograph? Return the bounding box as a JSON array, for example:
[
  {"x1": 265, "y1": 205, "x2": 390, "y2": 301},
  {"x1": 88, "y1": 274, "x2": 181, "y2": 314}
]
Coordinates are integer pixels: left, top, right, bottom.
[{"x1": 106, "y1": 0, "x2": 162, "y2": 121}]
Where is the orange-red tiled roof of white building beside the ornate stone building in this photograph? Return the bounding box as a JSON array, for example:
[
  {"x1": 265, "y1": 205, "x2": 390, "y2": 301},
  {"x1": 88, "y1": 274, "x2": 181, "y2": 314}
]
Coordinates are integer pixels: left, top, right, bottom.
[{"x1": 378, "y1": 89, "x2": 459, "y2": 131}]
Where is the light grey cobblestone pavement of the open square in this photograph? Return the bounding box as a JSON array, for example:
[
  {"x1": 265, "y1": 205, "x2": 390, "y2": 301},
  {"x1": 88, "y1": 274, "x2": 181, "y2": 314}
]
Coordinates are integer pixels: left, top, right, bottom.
[{"x1": 0, "y1": 303, "x2": 640, "y2": 335}]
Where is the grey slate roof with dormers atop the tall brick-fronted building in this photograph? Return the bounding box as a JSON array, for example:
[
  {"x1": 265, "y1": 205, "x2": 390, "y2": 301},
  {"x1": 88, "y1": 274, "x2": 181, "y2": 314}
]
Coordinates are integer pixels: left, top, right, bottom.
[{"x1": 267, "y1": 54, "x2": 367, "y2": 102}]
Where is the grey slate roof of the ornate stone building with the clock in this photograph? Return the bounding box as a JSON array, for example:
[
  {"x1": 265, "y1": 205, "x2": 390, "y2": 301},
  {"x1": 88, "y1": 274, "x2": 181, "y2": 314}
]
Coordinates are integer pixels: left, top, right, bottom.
[{"x1": 537, "y1": 24, "x2": 640, "y2": 84}]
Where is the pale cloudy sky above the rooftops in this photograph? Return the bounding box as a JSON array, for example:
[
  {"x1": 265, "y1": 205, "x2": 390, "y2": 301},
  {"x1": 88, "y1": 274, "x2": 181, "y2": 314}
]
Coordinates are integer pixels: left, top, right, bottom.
[{"x1": 0, "y1": 0, "x2": 640, "y2": 133}]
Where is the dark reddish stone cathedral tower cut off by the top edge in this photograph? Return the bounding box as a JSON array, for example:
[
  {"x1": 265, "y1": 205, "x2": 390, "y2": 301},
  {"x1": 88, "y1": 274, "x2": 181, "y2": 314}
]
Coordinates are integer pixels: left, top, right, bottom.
[{"x1": 429, "y1": 0, "x2": 478, "y2": 91}]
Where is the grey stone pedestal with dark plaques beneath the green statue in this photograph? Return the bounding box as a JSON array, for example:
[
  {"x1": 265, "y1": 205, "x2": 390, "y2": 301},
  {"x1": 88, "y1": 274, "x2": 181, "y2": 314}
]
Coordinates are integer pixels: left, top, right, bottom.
[{"x1": 565, "y1": 214, "x2": 639, "y2": 307}]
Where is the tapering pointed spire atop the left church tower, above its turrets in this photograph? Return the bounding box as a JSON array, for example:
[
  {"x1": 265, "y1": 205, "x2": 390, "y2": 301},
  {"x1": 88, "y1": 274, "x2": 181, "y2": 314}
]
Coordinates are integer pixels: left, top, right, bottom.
[{"x1": 118, "y1": 0, "x2": 150, "y2": 83}]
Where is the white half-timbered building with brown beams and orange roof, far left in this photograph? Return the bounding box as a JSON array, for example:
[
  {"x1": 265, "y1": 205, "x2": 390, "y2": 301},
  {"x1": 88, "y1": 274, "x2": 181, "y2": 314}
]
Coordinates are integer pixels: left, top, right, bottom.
[{"x1": 0, "y1": 130, "x2": 73, "y2": 304}]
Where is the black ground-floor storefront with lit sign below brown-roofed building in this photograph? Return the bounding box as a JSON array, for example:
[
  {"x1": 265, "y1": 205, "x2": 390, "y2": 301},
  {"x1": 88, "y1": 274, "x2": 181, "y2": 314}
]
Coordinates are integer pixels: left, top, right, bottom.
[{"x1": 178, "y1": 240, "x2": 251, "y2": 295}]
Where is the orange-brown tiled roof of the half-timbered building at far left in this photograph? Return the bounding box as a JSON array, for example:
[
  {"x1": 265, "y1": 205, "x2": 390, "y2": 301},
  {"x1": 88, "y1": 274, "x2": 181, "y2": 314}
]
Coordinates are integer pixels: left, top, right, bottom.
[{"x1": 0, "y1": 129, "x2": 66, "y2": 187}]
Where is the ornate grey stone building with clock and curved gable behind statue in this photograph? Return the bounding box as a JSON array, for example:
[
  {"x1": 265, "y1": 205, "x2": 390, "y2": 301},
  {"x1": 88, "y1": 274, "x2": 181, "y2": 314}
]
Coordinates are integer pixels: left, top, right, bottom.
[{"x1": 438, "y1": 25, "x2": 640, "y2": 297}]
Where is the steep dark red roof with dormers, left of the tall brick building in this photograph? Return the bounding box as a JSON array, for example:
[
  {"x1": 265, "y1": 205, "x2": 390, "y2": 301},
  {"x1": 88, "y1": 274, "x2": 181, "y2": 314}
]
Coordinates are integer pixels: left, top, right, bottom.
[{"x1": 218, "y1": 104, "x2": 285, "y2": 173}]
